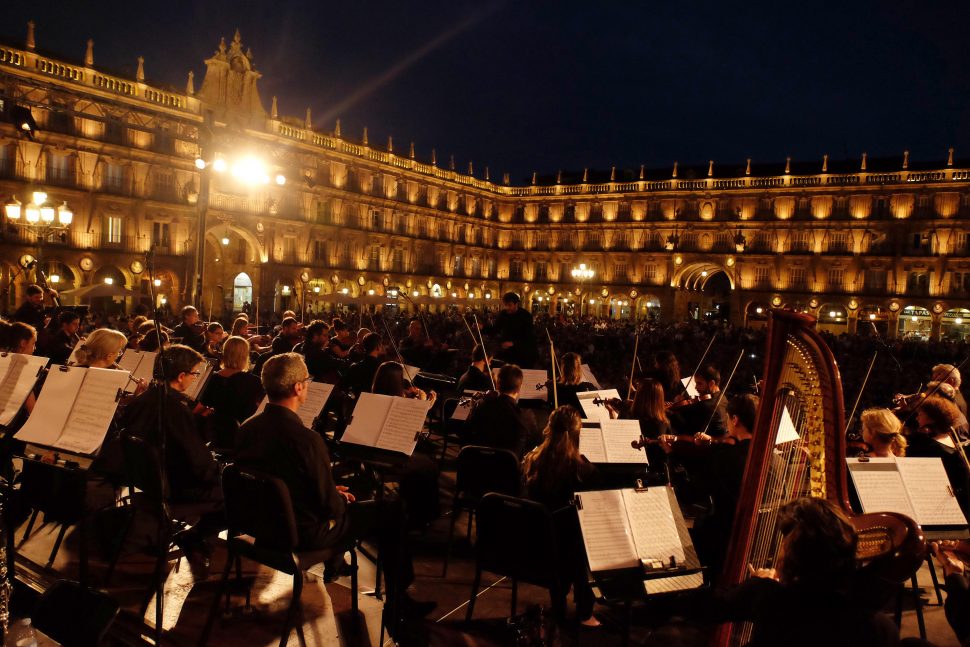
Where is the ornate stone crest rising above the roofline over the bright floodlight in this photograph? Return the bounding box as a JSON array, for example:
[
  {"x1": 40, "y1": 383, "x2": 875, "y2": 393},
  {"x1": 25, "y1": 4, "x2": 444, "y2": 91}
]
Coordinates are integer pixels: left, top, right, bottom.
[{"x1": 198, "y1": 29, "x2": 266, "y2": 128}]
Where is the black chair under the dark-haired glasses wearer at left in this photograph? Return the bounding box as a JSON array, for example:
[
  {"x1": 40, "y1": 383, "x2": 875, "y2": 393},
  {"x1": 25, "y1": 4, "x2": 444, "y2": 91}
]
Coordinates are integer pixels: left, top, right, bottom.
[{"x1": 105, "y1": 434, "x2": 213, "y2": 645}]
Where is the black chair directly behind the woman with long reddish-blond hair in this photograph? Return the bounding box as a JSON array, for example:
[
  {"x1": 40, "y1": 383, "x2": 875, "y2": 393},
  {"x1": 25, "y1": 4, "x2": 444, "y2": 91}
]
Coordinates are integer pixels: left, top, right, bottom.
[{"x1": 465, "y1": 493, "x2": 569, "y2": 622}]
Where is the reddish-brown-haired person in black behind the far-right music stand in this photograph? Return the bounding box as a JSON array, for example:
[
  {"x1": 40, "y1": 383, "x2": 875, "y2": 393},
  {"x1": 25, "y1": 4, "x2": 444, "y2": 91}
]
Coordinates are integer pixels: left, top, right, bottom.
[{"x1": 908, "y1": 395, "x2": 970, "y2": 516}]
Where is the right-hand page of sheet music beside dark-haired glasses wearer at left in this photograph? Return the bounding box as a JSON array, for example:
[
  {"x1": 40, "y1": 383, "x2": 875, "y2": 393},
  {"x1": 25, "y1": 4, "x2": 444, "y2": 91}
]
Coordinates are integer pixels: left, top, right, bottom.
[{"x1": 55, "y1": 368, "x2": 128, "y2": 455}]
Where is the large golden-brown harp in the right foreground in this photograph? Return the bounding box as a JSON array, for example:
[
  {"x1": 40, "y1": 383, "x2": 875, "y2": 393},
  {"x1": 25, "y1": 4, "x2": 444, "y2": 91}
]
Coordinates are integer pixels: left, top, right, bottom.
[{"x1": 715, "y1": 310, "x2": 926, "y2": 647}]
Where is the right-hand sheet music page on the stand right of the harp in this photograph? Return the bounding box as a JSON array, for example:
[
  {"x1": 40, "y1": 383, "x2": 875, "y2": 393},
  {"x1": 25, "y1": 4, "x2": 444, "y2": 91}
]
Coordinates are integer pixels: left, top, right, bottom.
[{"x1": 896, "y1": 458, "x2": 967, "y2": 526}]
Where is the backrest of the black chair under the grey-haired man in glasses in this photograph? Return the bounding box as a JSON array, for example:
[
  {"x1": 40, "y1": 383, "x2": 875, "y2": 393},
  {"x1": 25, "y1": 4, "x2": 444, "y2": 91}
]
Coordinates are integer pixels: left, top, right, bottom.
[{"x1": 222, "y1": 465, "x2": 299, "y2": 552}]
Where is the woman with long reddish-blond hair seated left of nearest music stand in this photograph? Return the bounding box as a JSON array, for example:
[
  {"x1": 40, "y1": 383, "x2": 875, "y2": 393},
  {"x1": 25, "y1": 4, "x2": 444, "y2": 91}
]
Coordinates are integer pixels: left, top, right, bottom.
[{"x1": 522, "y1": 405, "x2": 600, "y2": 627}]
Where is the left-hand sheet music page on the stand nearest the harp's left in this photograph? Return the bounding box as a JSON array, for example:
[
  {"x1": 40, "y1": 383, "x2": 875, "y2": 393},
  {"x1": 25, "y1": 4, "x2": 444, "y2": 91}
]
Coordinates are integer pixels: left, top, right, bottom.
[{"x1": 576, "y1": 490, "x2": 640, "y2": 572}]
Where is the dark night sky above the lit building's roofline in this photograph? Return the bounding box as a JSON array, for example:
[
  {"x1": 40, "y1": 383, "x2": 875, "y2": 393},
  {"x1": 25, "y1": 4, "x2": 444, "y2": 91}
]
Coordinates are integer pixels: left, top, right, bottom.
[{"x1": 0, "y1": 0, "x2": 970, "y2": 181}]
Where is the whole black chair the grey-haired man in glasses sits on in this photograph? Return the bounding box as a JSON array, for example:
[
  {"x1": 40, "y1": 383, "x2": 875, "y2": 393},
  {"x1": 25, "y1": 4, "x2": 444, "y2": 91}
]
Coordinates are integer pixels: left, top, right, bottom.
[{"x1": 199, "y1": 465, "x2": 358, "y2": 647}]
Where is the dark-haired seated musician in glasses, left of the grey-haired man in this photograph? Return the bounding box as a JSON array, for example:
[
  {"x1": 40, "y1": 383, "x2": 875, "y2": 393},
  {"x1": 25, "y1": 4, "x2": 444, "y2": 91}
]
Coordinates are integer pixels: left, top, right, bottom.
[{"x1": 120, "y1": 344, "x2": 225, "y2": 571}]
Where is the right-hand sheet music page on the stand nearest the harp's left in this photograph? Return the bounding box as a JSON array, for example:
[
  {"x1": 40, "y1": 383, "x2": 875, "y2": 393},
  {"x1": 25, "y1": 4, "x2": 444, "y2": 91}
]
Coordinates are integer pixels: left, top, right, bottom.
[{"x1": 622, "y1": 487, "x2": 685, "y2": 564}]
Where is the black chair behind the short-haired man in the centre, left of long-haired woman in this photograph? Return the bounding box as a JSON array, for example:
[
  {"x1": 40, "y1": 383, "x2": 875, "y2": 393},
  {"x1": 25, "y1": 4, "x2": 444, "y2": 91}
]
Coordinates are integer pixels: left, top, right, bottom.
[{"x1": 442, "y1": 445, "x2": 522, "y2": 577}]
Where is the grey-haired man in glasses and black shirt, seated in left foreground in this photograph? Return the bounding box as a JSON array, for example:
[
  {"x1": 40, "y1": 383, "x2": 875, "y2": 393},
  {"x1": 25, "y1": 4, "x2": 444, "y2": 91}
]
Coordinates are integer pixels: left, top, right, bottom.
[{"x1": 236, "y1": 353, "x2": 434, "y2": 616}]
